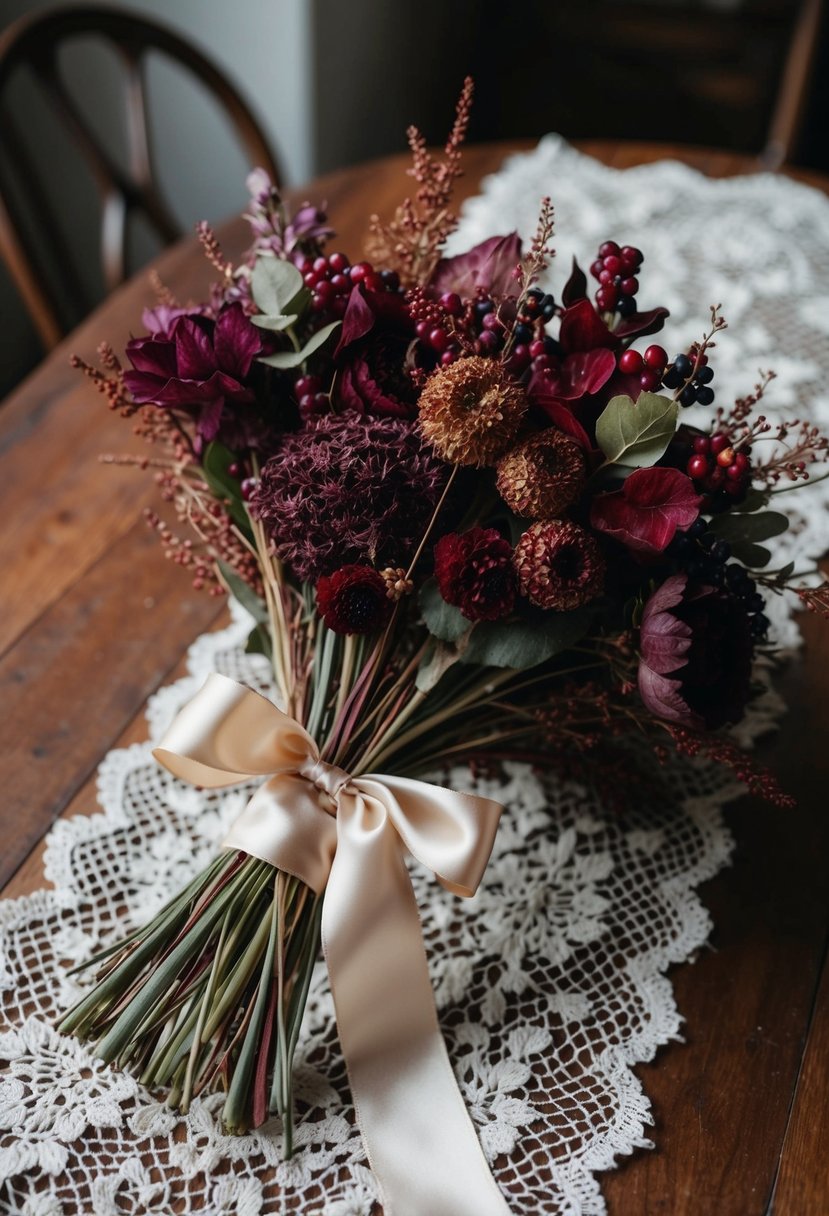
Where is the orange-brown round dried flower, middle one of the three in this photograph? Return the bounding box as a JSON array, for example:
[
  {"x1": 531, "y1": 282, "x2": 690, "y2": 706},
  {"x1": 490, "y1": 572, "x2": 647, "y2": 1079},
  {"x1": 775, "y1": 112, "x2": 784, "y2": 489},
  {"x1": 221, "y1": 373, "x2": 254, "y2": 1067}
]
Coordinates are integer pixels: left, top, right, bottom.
[{"x1": 498, "y1": 429, "x2": 586, "y2": 519}]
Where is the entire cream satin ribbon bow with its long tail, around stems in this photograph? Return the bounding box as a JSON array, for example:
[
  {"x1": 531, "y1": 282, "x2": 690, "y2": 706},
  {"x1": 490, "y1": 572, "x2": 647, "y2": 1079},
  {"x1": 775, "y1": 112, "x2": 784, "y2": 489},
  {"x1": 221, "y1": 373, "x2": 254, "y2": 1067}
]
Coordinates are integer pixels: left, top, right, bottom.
[{"x1": 153, "y1": 675, "x2": 509, "y2": 1216}]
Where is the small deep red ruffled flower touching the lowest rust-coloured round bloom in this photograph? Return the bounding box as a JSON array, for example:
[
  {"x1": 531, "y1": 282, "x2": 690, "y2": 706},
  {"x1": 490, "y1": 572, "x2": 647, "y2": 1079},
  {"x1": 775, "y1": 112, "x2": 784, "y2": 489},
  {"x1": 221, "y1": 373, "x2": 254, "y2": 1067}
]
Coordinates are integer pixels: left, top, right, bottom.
[{"x1": 435, "y1": 528, "x2": 515, "y2": 620}]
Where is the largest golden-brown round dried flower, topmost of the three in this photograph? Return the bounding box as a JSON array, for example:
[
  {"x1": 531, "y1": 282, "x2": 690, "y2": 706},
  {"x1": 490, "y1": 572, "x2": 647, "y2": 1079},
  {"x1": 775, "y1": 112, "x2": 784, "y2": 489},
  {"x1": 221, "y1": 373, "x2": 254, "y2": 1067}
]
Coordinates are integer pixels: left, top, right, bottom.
[{"x1": 418, "y1": 355, "x2": 526, "y2": 466}]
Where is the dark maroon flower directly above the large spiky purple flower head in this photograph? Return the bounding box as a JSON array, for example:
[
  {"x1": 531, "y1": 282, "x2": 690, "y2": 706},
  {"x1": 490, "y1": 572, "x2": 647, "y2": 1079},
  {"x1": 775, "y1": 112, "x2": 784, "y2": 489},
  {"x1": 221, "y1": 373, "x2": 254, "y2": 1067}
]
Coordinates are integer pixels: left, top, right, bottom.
[{"x1": 334, "y1": 283, "x2": 417, "y2": 418}]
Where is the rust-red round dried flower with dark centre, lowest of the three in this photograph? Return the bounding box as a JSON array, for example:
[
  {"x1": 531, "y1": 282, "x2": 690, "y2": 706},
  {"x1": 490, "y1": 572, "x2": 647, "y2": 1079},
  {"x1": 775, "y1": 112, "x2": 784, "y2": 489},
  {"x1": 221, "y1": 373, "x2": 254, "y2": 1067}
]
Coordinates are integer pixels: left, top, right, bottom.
[{"x1": 513, "y1": 519, "x2": 604, "y2": 612}]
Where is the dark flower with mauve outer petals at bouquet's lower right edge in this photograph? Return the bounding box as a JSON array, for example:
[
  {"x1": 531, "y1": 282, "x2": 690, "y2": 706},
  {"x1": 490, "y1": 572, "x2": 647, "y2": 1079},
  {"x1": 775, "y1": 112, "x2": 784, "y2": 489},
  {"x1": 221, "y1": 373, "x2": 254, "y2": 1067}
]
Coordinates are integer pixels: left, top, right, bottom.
[{"x1": 638, "y1": 574, "x2": 752, "y2": 731}]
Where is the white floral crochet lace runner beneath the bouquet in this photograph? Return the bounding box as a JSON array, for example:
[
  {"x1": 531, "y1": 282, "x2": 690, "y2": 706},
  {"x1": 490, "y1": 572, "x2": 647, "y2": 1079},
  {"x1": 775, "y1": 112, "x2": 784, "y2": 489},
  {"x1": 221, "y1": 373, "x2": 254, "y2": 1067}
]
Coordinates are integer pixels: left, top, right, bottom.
[{"x1": 0, "y1": 137, "x2": 829, "y2": 1216}]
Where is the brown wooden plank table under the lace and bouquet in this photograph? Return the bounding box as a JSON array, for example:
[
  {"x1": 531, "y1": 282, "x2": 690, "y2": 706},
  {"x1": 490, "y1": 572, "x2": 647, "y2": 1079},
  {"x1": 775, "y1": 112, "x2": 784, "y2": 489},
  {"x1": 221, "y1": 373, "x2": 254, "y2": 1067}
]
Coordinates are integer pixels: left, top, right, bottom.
[{"x1": 0, "y1": 143, "x2": 829, "y2": 1216}]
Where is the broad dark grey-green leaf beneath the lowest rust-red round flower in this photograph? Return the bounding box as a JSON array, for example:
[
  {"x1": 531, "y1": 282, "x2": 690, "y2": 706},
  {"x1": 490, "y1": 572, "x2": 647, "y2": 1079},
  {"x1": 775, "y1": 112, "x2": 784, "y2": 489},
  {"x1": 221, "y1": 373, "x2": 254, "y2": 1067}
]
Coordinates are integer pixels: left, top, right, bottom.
[{"x1": 461, "y1": 608, "x2": 593, "y2": 671}]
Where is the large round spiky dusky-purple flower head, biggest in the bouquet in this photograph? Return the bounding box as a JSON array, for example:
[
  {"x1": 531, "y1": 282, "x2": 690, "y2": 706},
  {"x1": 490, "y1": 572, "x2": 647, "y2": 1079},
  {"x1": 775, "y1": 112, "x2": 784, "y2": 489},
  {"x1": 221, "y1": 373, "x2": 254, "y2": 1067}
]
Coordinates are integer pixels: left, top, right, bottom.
[{"x1": 249, "y1": 413, "x2": 449, "y2": 582}]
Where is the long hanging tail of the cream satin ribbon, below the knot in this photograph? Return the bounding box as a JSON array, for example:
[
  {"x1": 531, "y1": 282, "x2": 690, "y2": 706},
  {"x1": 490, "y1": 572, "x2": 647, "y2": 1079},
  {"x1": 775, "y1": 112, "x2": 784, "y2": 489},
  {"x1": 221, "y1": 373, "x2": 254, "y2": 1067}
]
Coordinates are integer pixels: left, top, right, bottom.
[{"x1": 322, "y1": 792, "x2": 509, "y2": 1216}]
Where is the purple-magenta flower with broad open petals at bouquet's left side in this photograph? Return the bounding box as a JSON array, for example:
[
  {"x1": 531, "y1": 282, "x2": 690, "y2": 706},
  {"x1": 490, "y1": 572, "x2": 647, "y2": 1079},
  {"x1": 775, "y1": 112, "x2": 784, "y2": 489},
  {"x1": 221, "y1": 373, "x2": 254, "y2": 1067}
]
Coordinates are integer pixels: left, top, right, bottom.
[{"x1": 124, "y1": 304, "x2": 266, "y2": 445}]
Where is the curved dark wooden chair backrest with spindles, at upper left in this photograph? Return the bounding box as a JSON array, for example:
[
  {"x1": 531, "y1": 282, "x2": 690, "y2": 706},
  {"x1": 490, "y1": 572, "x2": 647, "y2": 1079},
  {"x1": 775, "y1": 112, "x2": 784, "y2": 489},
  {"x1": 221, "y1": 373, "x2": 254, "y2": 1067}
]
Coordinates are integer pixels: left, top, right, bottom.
[{"x1": 0, "y1": 6, "x2": 280, "y2": 348}]
